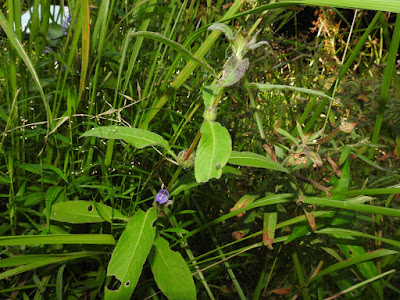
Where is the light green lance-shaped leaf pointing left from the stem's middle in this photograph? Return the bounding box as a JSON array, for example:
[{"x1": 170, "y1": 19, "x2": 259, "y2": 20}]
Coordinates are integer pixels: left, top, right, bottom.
[{"x1": 81, "y1": 126, "x2": 176, "y2": 158}]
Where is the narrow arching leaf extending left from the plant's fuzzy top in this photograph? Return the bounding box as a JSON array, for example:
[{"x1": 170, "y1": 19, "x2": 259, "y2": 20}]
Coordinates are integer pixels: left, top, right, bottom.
[{"x1": 130, "y1": 31, "x2": 216, "y2": 76}]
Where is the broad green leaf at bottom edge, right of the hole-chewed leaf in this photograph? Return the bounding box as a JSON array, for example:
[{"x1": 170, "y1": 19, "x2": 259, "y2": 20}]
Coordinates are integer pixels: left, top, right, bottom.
[{"x1": 149, "y1": 237, "x2": 196, "y2": 300}]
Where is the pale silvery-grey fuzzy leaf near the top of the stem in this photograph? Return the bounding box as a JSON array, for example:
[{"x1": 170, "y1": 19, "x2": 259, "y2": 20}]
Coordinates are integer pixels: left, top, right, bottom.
[{"x1": 218, "y1": 53, "x2": 249, "y2": 87}]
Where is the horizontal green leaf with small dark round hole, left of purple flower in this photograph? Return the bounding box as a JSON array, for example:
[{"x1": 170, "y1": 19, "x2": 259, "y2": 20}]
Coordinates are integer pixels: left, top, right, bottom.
[{"x1": 43, "y1": 200, "x2": 129, "y2": 224}]
